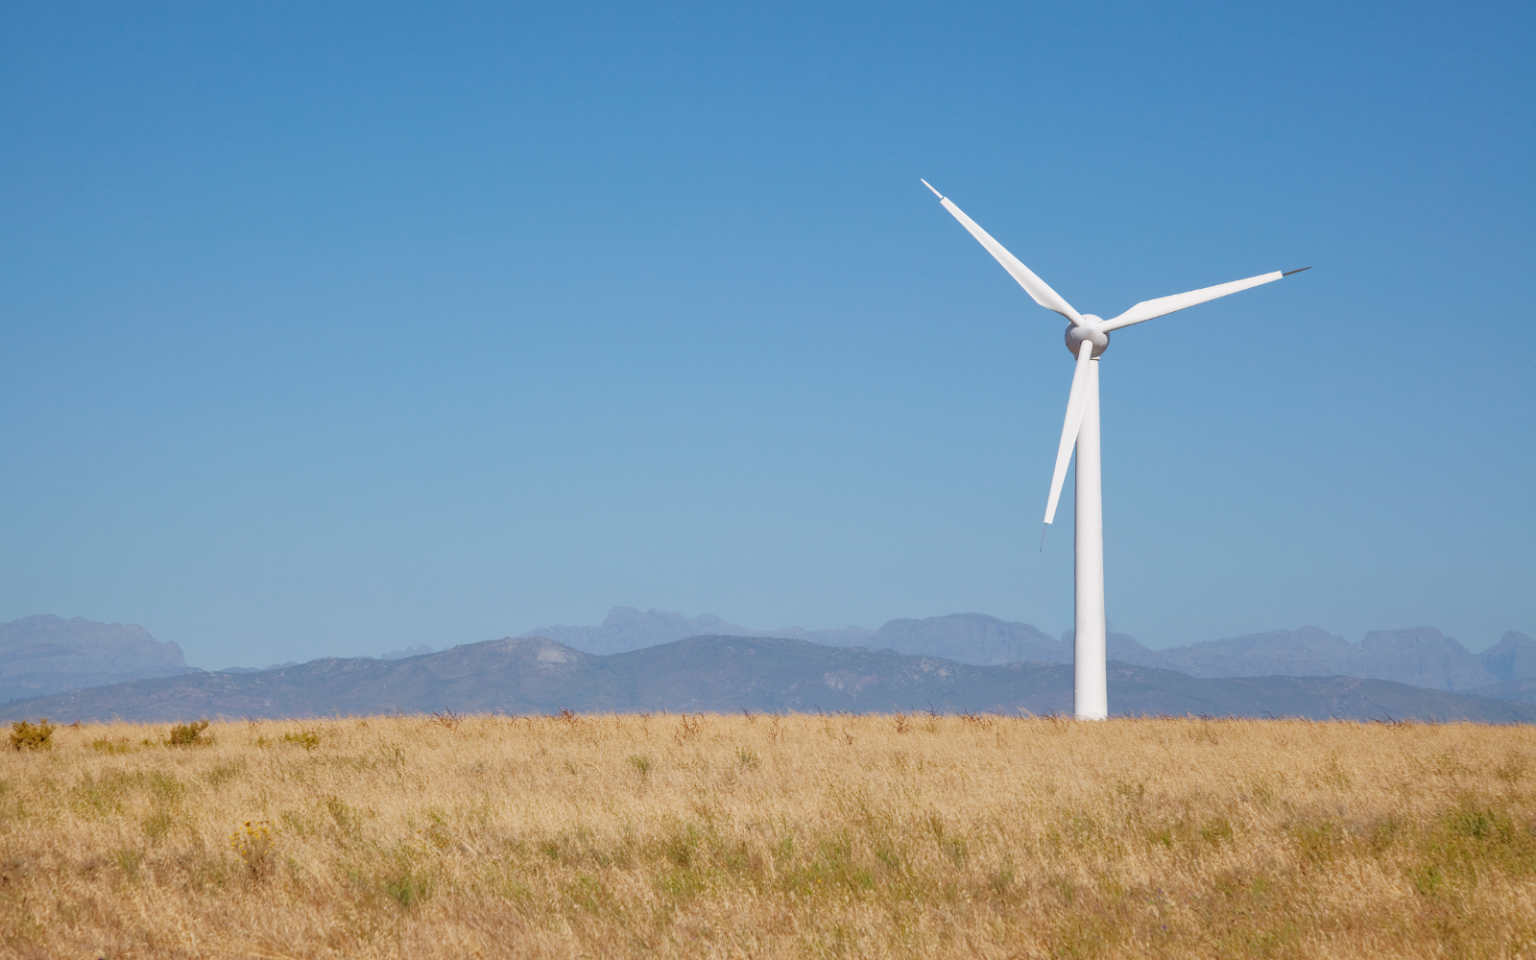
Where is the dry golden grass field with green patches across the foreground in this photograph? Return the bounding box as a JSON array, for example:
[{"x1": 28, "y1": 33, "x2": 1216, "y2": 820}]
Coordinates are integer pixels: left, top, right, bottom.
[{"x1": 0, "y1": 714, "x2": 1536, "y2": 960}]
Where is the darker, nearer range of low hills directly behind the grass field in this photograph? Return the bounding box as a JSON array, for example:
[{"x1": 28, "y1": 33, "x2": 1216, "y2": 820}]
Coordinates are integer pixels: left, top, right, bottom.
[{"x1": 0, "y1": 636, "x2": 1536, "y2": 723}]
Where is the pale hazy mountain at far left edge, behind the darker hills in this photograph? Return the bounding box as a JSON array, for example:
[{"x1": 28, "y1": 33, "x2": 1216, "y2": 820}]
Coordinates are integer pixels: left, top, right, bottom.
[{"x1": 0, "y1": 616, "x2": 192, "y2": 700}]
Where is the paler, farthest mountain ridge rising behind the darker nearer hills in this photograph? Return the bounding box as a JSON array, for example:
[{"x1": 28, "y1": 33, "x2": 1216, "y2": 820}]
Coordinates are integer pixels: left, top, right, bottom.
[{"x1": 14, "y1": 607, "x2": 1536, "y2": 700}]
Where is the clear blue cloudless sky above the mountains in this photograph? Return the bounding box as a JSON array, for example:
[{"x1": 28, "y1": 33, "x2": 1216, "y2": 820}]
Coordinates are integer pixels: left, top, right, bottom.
[{"x1": 0, "y1": 0, "x2": 1536, "y2": 667}]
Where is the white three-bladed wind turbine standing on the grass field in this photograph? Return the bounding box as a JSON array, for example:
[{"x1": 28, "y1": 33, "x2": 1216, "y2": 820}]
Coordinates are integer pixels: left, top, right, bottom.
[{"x1": 923, "y1": 180, "x2": 1312, "y2": 720}]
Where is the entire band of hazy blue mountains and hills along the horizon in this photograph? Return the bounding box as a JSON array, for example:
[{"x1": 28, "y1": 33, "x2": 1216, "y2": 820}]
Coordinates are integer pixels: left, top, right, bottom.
[{"x1": 0, "y1": 607, "x2": 1536, "y2": 722}]
